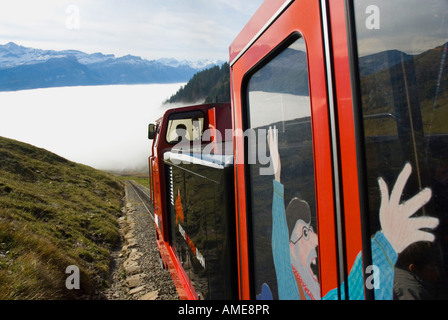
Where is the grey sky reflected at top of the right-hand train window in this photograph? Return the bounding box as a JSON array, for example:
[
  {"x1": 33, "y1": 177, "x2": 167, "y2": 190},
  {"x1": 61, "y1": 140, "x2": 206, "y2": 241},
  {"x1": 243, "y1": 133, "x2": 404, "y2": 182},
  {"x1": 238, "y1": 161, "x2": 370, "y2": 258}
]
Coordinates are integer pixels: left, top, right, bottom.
[{"x1": 354, "y1": 0, "x2": 448, "y2": 56}]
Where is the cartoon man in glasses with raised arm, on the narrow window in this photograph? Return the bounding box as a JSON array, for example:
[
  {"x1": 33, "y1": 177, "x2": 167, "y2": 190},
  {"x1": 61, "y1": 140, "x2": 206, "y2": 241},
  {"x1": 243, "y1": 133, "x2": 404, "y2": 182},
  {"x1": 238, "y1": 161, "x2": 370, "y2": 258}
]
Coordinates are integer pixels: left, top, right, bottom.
[{"x1": 266, "y1": 127, "x2": 320, "y2": 300}]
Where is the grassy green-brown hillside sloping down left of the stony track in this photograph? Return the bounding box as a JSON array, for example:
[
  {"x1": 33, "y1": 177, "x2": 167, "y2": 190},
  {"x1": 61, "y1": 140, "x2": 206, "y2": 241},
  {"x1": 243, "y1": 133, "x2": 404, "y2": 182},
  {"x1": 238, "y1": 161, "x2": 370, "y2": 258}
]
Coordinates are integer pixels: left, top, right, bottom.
[{"x1": 0, "y1": 137, "x2": 123, "y2": 299}]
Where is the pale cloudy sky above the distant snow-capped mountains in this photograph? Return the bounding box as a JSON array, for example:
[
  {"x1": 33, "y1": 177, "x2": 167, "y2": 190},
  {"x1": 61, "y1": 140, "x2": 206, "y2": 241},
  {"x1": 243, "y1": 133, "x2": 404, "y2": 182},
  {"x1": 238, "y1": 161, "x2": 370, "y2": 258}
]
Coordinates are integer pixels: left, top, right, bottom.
[{"x1": 0, "y1": 0, "x2": 263, "y2": 61}]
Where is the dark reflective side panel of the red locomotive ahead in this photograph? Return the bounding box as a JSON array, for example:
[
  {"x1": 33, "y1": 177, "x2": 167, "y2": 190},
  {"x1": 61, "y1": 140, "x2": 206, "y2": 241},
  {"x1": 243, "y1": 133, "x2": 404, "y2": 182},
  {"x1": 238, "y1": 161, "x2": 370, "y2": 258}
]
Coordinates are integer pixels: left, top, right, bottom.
[{"x1": 165, "y1": 160, "x2": 235, "y2": 300}]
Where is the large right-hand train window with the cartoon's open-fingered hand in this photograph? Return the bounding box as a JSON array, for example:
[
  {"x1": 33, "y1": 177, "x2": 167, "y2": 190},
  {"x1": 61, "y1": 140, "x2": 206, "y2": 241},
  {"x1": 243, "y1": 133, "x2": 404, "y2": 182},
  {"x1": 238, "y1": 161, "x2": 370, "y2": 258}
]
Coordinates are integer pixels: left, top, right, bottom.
[{"x1": 353, "y1": 0, "x2": 448, "y2": 299}]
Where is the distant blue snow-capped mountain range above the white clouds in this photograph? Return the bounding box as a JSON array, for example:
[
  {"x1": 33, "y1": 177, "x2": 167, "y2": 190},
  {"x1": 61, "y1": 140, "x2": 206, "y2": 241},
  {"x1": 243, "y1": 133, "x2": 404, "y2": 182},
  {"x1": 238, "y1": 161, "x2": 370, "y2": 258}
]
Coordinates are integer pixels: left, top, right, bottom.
[{"x1": 0, "y1": 42, "x2": 224, "y2": 91}]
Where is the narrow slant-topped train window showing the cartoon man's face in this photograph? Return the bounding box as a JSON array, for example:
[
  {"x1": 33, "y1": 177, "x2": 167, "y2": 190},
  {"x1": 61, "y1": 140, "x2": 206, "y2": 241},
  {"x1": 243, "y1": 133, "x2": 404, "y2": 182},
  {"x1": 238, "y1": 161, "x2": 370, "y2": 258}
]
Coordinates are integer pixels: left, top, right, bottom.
[{"x1": 246, "y1": 37, "x2": 320, "y2": 299}]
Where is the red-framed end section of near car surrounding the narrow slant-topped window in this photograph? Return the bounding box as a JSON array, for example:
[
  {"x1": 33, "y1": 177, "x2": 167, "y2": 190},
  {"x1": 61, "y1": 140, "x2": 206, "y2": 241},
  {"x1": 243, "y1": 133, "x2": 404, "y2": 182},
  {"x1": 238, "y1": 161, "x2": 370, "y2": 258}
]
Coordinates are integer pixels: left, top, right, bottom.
[{"x1": 230, "y1": 0, "x2": 343, "y2": 299}]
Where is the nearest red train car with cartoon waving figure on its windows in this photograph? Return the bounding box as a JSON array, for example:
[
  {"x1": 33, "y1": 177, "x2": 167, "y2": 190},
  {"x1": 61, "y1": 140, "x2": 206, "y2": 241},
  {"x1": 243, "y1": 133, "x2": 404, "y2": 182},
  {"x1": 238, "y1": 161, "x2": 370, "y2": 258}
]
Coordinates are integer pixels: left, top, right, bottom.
[{"x1": 153, "y1": 0, "x2": 448, "y2": 300}]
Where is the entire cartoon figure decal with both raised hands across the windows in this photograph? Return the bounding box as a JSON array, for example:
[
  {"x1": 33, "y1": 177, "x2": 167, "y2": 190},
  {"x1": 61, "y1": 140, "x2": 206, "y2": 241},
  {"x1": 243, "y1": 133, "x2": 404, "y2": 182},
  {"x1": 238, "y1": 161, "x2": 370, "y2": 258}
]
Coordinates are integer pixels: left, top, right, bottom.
[{"x1": 257, "y1": 127, "x2": 439, "y2": 300}]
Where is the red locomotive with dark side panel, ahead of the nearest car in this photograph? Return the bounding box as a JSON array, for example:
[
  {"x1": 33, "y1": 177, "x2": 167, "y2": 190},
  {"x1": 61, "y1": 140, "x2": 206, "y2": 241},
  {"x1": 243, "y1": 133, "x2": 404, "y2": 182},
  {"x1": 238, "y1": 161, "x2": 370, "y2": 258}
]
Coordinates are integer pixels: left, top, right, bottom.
[{"x1": 148, "y1": 103, "x2": 237, "y2": 299}]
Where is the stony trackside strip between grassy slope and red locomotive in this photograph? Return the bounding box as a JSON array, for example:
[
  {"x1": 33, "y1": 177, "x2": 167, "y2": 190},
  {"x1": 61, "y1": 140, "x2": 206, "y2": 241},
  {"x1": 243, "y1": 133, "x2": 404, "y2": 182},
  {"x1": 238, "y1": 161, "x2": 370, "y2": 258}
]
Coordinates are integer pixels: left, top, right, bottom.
[{"x1": 104, "y1": 181, "x2": 179, "y2": 300}]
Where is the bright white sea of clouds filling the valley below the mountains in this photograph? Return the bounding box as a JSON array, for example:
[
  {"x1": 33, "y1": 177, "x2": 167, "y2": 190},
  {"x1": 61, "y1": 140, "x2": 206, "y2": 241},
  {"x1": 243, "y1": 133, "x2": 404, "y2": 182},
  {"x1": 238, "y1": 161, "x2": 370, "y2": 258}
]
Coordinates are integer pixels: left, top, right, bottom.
[{"x1": 0, "y1": 83, "x2": 185, "y2": 171}]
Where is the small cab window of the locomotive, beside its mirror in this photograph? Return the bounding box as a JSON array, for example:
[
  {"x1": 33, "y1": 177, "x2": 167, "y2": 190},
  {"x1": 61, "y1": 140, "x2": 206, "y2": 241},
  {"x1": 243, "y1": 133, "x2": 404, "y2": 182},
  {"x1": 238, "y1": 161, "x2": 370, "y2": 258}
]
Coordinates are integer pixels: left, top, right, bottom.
[{"x1": 166, "y1": 111, "x2": 204, "y2": 144}]
